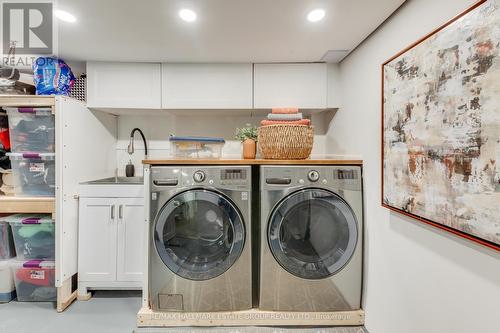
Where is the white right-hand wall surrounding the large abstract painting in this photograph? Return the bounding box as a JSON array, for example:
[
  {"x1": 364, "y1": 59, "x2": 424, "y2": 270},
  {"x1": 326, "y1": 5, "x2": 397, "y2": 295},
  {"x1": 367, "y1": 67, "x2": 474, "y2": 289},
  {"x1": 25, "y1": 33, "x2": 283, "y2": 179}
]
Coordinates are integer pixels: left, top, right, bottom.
[{"x1": 326, "y1": 0, "x2": 500, "y2": 333}]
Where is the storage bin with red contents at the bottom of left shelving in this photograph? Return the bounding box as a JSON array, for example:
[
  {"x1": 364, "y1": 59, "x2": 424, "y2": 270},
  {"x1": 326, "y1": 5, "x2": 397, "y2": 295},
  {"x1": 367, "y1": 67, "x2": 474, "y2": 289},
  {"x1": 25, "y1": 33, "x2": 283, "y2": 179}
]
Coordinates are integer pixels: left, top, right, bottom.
[{"x1": 12, "y1": 260, "x2": 57, "y2": 302}]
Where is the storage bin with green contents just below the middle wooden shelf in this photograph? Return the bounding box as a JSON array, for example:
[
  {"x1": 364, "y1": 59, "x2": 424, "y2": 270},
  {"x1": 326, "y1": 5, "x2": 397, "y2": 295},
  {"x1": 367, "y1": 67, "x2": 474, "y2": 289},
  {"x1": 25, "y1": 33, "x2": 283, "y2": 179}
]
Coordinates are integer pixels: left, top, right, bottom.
[{"x1": 4, "y1": 214, "x2": 56, "y2": 261}]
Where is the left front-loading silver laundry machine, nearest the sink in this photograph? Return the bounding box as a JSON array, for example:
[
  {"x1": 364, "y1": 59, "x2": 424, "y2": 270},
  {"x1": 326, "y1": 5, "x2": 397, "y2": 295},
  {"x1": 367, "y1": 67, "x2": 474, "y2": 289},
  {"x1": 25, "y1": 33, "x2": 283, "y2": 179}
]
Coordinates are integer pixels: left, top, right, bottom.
[{"x1": 149, "y1": 166, "x2": 252, "y2": 312}]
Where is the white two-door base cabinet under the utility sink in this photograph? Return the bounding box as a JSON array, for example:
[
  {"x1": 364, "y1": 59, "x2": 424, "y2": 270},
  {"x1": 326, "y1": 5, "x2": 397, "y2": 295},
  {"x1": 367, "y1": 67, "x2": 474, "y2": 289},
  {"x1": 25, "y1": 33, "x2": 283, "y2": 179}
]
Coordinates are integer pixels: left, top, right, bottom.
[{"x1": 78, "y1": 192, "x2": 145, "y2": 298}]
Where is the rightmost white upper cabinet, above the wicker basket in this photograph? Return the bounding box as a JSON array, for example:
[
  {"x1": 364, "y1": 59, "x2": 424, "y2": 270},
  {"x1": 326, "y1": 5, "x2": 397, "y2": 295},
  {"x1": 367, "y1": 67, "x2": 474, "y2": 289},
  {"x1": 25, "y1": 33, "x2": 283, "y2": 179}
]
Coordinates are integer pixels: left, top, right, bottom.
[{"x1": 253, "y1": 63, "x2": 328, "y2": 109}]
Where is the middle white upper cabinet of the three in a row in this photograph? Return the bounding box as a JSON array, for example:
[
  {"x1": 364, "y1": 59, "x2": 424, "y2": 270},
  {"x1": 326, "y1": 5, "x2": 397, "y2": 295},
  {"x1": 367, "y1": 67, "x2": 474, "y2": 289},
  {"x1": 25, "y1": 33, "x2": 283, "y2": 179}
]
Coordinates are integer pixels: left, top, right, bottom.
[{"x1": 162, "y1": 63, "x2": 252, "y2": 109}]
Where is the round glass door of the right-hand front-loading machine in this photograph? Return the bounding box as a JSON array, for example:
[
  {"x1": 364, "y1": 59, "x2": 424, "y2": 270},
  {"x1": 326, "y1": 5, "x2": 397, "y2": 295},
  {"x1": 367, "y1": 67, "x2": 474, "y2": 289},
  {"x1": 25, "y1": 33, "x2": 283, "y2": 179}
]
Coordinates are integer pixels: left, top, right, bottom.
[{"x1": 268, "y1": 189, "x2": 358, "y2": 279}]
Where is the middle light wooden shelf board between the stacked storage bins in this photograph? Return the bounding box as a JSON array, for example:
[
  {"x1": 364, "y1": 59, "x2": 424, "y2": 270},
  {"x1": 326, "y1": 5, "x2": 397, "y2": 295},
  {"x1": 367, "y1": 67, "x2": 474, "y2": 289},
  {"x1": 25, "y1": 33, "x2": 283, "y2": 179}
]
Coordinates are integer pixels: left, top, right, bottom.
[{"x1": 0, "y1": 196, "x2": 55, "y2": 214}]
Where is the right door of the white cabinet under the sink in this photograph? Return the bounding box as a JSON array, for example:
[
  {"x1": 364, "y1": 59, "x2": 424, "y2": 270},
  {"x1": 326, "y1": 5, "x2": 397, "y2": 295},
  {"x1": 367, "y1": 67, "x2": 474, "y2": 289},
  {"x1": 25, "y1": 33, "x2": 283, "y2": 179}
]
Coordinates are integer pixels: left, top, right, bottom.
[{"x1": 116, "y1": 198, "x2": 145, "y2": 282}]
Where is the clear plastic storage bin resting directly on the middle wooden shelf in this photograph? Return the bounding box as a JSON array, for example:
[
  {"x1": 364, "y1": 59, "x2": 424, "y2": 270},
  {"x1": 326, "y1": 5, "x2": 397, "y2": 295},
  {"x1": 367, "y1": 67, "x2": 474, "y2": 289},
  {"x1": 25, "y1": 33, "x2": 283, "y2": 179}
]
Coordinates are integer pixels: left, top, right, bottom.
[{"x1": 7, "y1": 153, "x2": 56, "y2": 197}]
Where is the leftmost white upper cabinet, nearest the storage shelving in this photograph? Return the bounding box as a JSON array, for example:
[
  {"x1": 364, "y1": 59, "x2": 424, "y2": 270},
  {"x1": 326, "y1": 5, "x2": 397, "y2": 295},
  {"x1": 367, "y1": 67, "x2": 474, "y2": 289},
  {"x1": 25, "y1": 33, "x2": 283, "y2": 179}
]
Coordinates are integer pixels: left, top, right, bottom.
[{"x1": 87, "y1": 62, "x2": 161, "y2": 109}]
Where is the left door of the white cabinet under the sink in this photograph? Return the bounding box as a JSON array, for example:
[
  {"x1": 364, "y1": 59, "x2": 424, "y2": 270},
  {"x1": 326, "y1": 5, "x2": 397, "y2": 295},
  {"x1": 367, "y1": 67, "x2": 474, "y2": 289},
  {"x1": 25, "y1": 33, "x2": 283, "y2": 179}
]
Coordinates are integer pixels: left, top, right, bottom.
[{"x1": 78, "y1": 198, "x2": 117, "y2": 281}]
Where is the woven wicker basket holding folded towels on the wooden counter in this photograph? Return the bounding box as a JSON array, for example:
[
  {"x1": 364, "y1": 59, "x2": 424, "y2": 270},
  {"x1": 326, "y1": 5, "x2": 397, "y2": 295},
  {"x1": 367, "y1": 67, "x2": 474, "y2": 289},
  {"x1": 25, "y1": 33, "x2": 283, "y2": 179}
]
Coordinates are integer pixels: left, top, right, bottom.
[{"x1": 258, "y1": 124, "x2": 313, "y2": 160}]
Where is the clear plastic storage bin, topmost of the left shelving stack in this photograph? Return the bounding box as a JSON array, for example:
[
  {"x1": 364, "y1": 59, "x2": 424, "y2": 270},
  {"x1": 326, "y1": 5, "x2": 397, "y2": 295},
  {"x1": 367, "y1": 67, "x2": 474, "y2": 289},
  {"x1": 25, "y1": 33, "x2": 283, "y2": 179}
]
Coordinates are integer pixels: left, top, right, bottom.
[{"x1": 4, "y1": 107, "x2": 55, "y2": 153}]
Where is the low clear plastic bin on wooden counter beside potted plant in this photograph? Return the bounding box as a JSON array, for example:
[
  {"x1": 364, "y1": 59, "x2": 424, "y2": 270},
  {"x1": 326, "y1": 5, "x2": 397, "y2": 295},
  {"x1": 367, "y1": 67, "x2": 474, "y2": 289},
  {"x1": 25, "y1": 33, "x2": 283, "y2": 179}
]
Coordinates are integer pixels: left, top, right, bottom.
[{"x1": 170, "y1": 136, "x2": 225, "y2": 159}]
